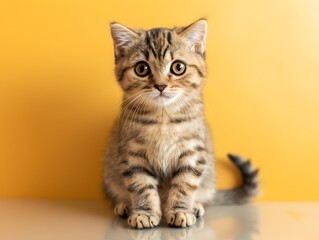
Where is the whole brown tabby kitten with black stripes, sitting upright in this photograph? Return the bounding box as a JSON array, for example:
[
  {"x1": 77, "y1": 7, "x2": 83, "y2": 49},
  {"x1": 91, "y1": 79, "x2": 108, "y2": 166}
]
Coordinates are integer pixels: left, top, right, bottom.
[{"x1": 104, "y1": 19, "x2": 258, "y2": 229}]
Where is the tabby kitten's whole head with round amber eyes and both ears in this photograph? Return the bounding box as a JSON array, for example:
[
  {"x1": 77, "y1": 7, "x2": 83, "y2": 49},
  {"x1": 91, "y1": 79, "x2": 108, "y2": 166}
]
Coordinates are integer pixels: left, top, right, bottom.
[{"x1": 111, "y1": 20, "x2": 207, "y2": 107}]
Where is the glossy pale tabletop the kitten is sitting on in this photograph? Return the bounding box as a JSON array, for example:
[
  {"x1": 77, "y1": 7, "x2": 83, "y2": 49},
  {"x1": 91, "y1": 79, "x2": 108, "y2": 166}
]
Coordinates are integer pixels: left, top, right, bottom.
[{"x1": 0, "y1": 199, "x2": 319, "y2": 240}]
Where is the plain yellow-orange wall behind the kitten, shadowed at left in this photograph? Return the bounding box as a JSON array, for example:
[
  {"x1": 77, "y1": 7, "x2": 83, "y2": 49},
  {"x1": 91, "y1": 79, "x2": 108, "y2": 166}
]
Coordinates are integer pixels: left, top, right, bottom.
[{"x1": 0, "y1": 0, "x2": 319, "y2": 200}]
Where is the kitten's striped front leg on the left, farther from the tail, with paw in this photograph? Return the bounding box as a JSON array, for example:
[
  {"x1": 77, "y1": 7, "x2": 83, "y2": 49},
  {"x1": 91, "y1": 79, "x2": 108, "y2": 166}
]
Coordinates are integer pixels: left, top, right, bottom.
[{"x1": 122, "y1": 164, "x2": 162, "y2": 229}]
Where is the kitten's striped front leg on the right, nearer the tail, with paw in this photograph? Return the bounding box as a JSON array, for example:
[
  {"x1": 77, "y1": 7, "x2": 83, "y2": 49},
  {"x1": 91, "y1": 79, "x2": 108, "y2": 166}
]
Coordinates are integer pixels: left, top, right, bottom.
[{"x1": 165, "y1": 151, "x2": 206, "y2": 227}]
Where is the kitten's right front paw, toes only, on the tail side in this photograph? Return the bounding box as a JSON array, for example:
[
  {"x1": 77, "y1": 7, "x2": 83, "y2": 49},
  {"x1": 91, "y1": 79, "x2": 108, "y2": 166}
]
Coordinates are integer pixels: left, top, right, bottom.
[{"x1": 166, "y1": 212, "x2": 196, "y2": 227}]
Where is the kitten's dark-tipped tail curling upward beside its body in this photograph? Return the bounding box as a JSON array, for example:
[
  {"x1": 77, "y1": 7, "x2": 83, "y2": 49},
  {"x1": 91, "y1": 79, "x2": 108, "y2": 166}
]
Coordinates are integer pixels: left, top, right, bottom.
[{"x1": 212, "y1": 154, "x2": 259, "y2": 205}]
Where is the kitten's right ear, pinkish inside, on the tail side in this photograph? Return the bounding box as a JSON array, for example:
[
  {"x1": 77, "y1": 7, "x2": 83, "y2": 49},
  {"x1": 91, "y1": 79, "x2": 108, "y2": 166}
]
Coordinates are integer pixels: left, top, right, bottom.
[{"x1": 179, "y1": 19, "x2": 207, "y2": 54}]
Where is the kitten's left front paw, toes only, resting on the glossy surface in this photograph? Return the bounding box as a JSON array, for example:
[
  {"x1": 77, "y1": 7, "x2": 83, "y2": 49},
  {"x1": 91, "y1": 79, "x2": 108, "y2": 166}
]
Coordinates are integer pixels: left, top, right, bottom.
[{"x1": 127, "y1": 213, "x2": 161, "y2": 229}]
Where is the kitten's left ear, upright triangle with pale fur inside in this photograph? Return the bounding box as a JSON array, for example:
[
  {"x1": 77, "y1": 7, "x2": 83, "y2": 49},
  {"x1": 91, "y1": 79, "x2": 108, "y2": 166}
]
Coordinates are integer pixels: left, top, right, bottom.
[{"x1": 110, "y1": 22, "x2": 138, "y2": 56}]
